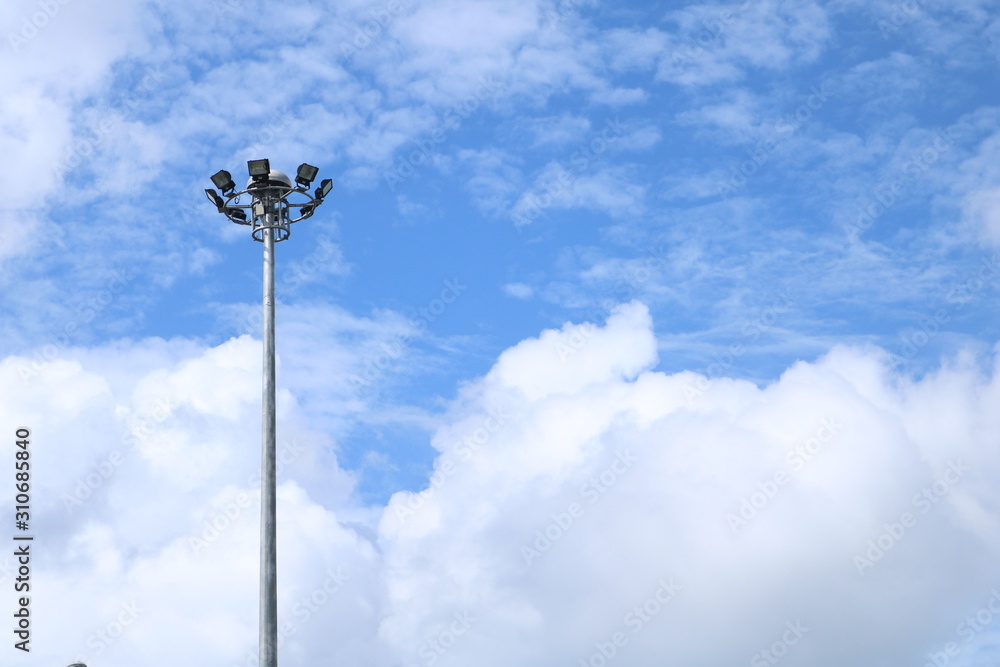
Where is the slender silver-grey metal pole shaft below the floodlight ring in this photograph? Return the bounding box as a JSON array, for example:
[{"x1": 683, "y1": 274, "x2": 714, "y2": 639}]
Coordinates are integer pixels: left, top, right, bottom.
[{"x1": 258, "y1": 226, "x2": 278, "y2": 667}]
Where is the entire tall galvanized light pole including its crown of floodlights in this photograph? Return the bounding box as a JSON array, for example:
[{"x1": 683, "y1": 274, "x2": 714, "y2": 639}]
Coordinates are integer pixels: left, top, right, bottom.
[{"x1": 205, "y1": 160, "x2": 333, "y2": 667}]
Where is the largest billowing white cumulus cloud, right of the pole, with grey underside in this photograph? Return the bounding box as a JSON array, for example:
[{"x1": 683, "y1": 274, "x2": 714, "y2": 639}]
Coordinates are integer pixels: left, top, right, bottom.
[{"x1": 382, "y1": 307, "x2": 1000, "y2": 665}]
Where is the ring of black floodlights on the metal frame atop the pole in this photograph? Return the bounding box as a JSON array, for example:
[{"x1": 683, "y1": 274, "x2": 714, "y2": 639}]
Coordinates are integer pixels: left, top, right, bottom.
[{"x1": 205, "y1": 159, "x2": 333, "y2": 241}]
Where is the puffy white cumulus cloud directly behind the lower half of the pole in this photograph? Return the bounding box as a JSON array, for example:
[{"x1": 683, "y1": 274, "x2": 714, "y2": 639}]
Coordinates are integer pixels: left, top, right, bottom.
[{"x1": 0, "y1": 330, "x2": 372, "y2": 665}]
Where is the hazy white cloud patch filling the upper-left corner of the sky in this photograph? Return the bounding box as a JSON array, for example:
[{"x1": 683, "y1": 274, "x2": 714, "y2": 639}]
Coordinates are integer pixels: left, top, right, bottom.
[{"x1": 0, "y1": 0, "x2": 150, "y2": 259}]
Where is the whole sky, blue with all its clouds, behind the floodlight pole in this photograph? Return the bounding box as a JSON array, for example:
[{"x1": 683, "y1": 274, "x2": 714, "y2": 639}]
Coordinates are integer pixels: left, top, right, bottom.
[{"x1": 0, "y1": 0, "x2": 1000, "y2": 667}]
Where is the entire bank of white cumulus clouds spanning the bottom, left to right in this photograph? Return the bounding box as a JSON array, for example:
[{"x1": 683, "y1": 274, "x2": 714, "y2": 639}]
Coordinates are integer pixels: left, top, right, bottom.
[{"x1": 0, "y1": 302, "x2": 1000, "y2": 667}]
